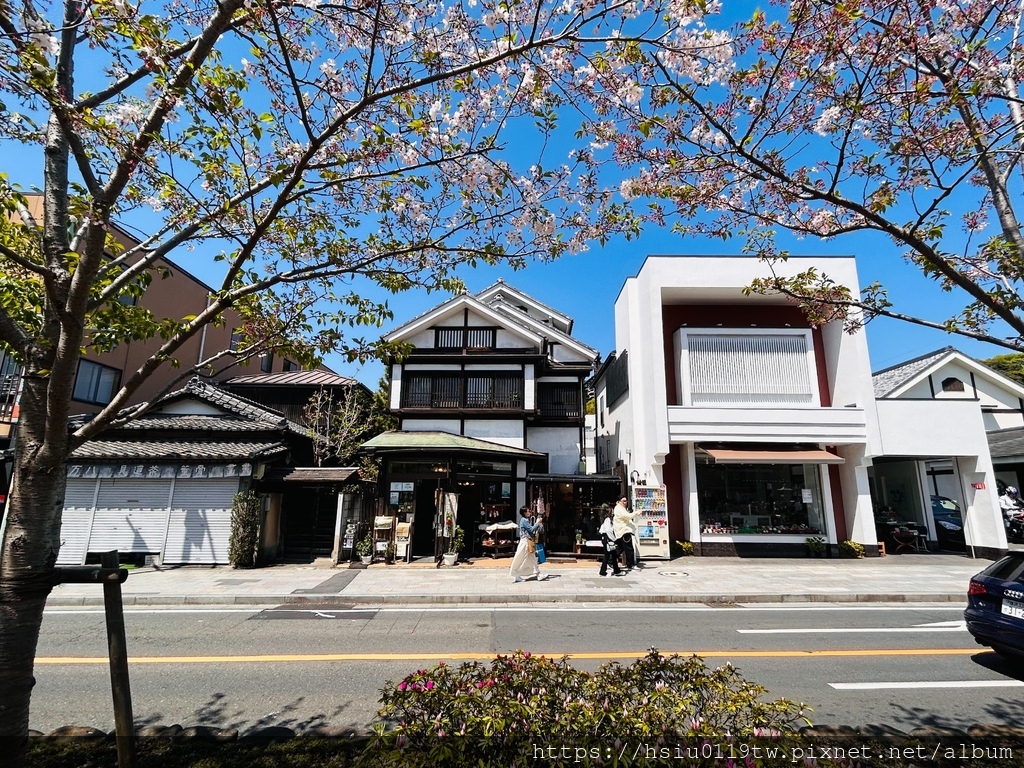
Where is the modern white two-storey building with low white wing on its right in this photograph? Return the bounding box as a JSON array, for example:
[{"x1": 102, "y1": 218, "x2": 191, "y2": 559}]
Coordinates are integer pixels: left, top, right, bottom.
[{"x1": 596, "y1": 256, "x2": 1006, "y2": 556}]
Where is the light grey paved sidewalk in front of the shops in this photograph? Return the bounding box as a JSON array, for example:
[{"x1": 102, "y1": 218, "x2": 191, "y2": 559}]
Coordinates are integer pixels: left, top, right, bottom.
[{"x1": 47, "y1": 554, "x2": 990, "y2": 606}]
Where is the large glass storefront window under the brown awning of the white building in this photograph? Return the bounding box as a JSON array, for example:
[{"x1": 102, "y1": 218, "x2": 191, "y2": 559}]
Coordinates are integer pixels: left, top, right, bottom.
[{"x1": 696, "y1": 461, "x2": 825, "y2": 536}]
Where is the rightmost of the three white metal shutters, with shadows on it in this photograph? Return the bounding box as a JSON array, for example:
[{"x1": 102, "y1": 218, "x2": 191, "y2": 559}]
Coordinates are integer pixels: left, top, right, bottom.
[{"x1": 164, "y1": 477, "x2": 239, "y2": 565}]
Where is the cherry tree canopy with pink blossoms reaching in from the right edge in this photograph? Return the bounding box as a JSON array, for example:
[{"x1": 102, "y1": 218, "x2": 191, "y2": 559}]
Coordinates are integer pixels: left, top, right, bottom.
[{"x1": 591, "y1": 0, "x2": 1024, "y2": 349}]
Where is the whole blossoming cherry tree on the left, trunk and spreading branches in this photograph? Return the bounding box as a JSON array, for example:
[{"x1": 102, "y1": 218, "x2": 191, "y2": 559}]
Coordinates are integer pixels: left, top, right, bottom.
[{"x1": 0, "y1": 0, "x2": 722, "y2": 766}]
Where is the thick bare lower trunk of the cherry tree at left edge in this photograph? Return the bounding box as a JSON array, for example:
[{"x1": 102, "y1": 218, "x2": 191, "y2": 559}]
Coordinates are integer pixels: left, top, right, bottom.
[{"x1": 0, "y1": 375, "x2": 69, "y2": 768}]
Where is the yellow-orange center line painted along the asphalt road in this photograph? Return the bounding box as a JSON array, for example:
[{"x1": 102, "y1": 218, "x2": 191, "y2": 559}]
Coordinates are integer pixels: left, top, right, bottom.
[{"x1": 36, "y1": 648, "x2": 985, "y2": 665}]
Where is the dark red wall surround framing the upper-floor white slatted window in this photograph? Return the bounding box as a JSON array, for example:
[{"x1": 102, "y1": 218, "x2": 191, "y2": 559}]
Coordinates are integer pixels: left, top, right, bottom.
[{"x1": 662, "y1": 304, "x2": 831, "y2": 408}]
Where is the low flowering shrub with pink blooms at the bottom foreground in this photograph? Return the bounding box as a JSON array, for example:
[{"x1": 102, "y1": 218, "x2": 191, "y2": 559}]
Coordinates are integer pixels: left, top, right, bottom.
[{"x1": 359, "y1": 650, "x2": 808, "y2": 768}]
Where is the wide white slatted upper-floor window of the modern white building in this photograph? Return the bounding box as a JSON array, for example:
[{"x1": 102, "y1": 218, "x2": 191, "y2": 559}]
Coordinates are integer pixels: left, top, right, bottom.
[{"x1": 684, "y1": 333, "x2": 815, "y2": 406}]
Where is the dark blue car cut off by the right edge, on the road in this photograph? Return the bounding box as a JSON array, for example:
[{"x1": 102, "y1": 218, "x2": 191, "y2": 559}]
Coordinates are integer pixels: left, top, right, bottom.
[{"x1": 964, "y1": 552, "x2": 1024, "y2": 660}]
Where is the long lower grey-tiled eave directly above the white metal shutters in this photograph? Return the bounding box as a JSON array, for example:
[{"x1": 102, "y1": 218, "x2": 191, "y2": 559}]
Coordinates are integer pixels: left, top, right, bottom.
[{"x1": 71, "y1": 437, "x2": 288, "y2": 461}]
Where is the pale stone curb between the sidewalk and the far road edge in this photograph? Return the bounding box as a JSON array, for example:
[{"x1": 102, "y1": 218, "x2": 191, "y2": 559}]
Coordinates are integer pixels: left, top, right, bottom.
[{"x1": 46, "y1": 592, "x2": 967, "y2": 607}]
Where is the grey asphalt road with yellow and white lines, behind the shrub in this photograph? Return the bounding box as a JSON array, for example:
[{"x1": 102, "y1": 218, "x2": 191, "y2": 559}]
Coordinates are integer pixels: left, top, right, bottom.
[{"x1": 31, "y1": 604, "x2": 1024, "y2": 731}]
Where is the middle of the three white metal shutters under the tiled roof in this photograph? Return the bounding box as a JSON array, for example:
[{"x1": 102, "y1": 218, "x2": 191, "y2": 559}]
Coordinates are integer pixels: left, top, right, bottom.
[{"x1": 89, "y1": 479, "x2": 171, "y2": 554}]
